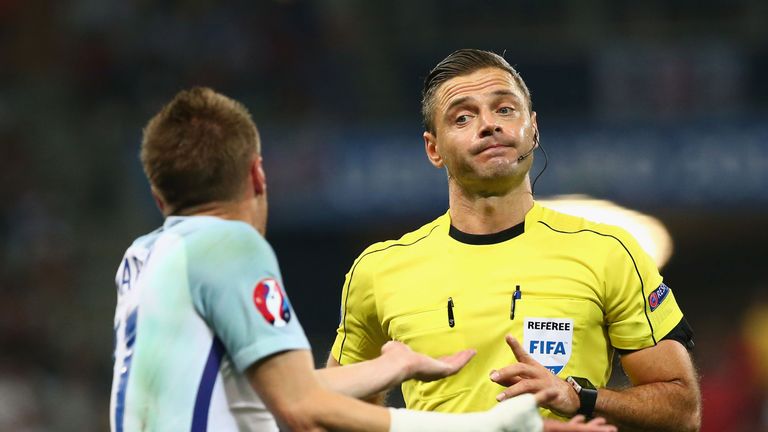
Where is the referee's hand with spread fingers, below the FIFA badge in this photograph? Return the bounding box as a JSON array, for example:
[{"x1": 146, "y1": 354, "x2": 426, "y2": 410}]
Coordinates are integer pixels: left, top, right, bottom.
[{"x1": 491, "y1": 335, "x2": 579, "y2": 416}]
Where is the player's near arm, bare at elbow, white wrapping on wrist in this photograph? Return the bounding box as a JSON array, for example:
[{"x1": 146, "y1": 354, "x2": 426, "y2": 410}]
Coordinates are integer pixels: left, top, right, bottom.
[{"x1": 246, "y1": 350, "x2": 551, "y2": 432}]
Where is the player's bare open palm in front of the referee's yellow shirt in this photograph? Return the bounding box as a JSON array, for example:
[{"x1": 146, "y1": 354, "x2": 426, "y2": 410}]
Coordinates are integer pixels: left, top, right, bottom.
[{"x1": 381, "y1": 341, "x2": 476, "y2": 382}]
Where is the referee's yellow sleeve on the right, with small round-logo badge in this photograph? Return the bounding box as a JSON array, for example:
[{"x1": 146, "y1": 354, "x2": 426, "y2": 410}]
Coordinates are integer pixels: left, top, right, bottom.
[{"x1": 605, "y1": 228, "x2": 683, "y2": 350}]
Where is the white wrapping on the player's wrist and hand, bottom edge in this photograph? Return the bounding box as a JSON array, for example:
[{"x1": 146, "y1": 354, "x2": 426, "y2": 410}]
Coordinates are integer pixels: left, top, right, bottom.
[{"x1": 389, "y1": 394, "x2": 543, "y2": 432}]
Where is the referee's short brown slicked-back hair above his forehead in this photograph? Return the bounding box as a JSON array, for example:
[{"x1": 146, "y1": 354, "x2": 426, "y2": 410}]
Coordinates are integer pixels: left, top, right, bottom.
[{"x1": 421, "y1": 48, "x2": 532, "y2": 133}]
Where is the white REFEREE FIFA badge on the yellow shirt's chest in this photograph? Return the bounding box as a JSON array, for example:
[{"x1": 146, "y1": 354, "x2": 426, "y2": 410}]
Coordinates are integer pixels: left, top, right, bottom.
[{"x1": 523, "y1": 318, "x2": 573, "y2": 375}]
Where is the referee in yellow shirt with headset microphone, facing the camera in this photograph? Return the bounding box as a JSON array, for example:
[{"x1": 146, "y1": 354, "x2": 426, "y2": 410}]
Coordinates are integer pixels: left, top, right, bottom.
[{"x1": 328, "y1": 49, "x2": 701, "y2": 431}]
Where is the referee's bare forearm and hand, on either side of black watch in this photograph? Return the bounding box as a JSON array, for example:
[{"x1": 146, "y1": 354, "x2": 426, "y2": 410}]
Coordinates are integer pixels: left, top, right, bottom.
[{"x1": 491, "y1": 336, "x2": 701, "y2": 431}]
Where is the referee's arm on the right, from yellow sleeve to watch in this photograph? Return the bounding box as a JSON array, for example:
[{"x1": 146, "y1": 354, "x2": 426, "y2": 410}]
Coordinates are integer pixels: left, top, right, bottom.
[{"x1": 594, "y1": 230, "x2": 701, "y2": 431}]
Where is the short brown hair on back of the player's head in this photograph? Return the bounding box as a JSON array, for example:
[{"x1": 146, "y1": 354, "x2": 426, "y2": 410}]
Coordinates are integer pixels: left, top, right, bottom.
[{"x1": 141, "y1": 87, "x2": 261, "y2": 214}]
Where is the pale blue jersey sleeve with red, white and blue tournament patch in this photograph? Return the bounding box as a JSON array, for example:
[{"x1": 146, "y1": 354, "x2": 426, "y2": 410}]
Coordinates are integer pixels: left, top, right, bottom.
[{"x1": 190, "y1": 224, "x2": 309, "y2": 372}]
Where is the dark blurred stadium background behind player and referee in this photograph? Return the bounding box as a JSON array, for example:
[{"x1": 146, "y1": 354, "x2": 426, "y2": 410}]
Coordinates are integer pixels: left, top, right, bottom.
[{"x1": 0, "y1": 0, "x2": 768, "y2": 431}]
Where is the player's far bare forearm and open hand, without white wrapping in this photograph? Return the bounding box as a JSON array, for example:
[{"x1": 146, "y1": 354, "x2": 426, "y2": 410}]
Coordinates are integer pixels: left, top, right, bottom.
[{"x1": 316, "y1": 341, "x2": 475, "y2": 402}]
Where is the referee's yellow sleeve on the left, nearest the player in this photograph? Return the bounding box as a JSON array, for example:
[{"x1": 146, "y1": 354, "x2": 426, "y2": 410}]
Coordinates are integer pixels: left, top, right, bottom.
[{"x1": 331, "y1": 253, "x2": 389, "y2": 365}]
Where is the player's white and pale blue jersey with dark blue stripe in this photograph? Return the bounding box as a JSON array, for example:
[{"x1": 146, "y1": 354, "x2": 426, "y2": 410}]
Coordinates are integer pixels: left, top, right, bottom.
[{"x1": 110, "y1": 216, "x2": 309, "y2": 432}]
